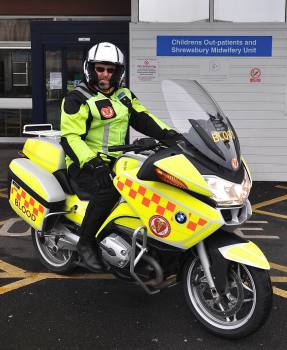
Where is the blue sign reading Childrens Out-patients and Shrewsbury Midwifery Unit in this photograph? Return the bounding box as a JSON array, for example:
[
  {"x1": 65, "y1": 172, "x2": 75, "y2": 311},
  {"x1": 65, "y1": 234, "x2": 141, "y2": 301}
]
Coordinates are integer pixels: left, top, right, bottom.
[{"x1": 157, "y1": 35, "x2": 272, "y2": 57}]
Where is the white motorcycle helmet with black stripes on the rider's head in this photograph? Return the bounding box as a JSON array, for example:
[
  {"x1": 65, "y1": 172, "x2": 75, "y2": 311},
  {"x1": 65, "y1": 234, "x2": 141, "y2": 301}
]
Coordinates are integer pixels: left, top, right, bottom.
[{"x1": 83, "y1": 42, "x2": 125, "y2": 88}]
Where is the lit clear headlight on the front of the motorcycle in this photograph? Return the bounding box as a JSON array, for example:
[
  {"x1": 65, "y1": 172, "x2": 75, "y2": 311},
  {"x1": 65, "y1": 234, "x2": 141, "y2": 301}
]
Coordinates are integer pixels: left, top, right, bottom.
[{"x1": 203, "y1": 170, "x2": 251, "y2": 206}]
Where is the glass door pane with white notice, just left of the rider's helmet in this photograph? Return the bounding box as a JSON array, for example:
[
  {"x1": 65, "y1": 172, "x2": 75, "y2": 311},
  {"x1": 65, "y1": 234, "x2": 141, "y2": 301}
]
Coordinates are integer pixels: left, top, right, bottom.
[{"x1": 45, "y1": 47, "x2": 86, "y2": 129}]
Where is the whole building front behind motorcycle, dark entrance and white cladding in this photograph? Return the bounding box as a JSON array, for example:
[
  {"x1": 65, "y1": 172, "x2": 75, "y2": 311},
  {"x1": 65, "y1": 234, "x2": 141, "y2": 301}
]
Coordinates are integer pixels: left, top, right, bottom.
[{"x1": 0, "y1": 0, "x2": 287, "y2": 181}]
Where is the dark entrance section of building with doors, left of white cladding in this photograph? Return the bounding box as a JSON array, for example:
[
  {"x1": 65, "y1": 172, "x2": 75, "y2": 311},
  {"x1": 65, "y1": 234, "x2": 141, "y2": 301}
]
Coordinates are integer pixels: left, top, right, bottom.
[{"x1": 0, "y1": 0, "x2": 131, "y2": 135}]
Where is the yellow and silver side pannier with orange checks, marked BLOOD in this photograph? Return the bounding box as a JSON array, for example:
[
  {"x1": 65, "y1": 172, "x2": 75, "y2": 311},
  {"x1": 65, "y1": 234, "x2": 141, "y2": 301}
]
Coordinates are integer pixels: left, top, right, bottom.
[{"x1": 9, "y1": 158, "x2": 66, "y2": 231}]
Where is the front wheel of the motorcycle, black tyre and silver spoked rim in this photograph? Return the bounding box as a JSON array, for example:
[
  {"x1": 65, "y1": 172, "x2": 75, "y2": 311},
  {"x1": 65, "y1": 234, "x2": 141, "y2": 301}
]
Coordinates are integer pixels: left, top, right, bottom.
[{"x1": 183, "y1": 258, "x2": 272, "y2": 339}]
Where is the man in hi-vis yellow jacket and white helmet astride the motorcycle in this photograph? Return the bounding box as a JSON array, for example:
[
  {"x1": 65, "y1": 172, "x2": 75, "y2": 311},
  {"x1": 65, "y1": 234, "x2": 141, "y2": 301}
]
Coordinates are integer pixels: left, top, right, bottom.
[{"x1": 61, "y1": 42, "x2": 179, "y2": 271}]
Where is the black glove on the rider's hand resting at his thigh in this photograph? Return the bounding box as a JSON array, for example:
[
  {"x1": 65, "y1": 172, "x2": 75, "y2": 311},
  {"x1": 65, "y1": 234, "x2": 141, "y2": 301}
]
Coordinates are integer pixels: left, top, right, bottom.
[{"x1": 84, "y1": 157, "x2": 113, "y2": 189}]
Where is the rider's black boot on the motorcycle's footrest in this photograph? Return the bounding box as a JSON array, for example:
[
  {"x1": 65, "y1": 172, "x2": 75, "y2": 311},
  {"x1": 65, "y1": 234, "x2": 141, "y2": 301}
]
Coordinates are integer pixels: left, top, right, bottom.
[{"x1": 77, "y1": 237, "x2": 105, "y2": 272}]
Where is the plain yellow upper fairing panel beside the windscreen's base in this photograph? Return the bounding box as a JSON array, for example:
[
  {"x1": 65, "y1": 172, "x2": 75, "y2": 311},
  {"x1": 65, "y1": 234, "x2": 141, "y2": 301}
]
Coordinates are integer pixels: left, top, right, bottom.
[{"x1": 154, "y1": 154, "x2": 212, "y2": 197}]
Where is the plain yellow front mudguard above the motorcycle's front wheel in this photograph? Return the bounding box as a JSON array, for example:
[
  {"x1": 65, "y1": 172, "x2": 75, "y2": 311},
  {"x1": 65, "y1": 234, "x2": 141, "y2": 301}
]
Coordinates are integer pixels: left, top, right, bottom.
[{"x1": 219, "y1": 242, "x2": 270, "y2": 270}]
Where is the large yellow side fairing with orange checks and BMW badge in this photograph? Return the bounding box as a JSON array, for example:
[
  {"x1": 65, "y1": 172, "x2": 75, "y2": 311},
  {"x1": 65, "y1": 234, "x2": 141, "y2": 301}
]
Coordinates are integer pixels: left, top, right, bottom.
[{"x1": 114, "y1": 164, "x2": 223, "y2": 249}]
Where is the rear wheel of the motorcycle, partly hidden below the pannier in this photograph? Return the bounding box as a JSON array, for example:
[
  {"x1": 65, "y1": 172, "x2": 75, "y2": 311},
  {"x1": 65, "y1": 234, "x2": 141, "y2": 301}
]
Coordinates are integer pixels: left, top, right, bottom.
[{"x1": 31, "y1": 228, "x2": 78, "y2": 274}]
